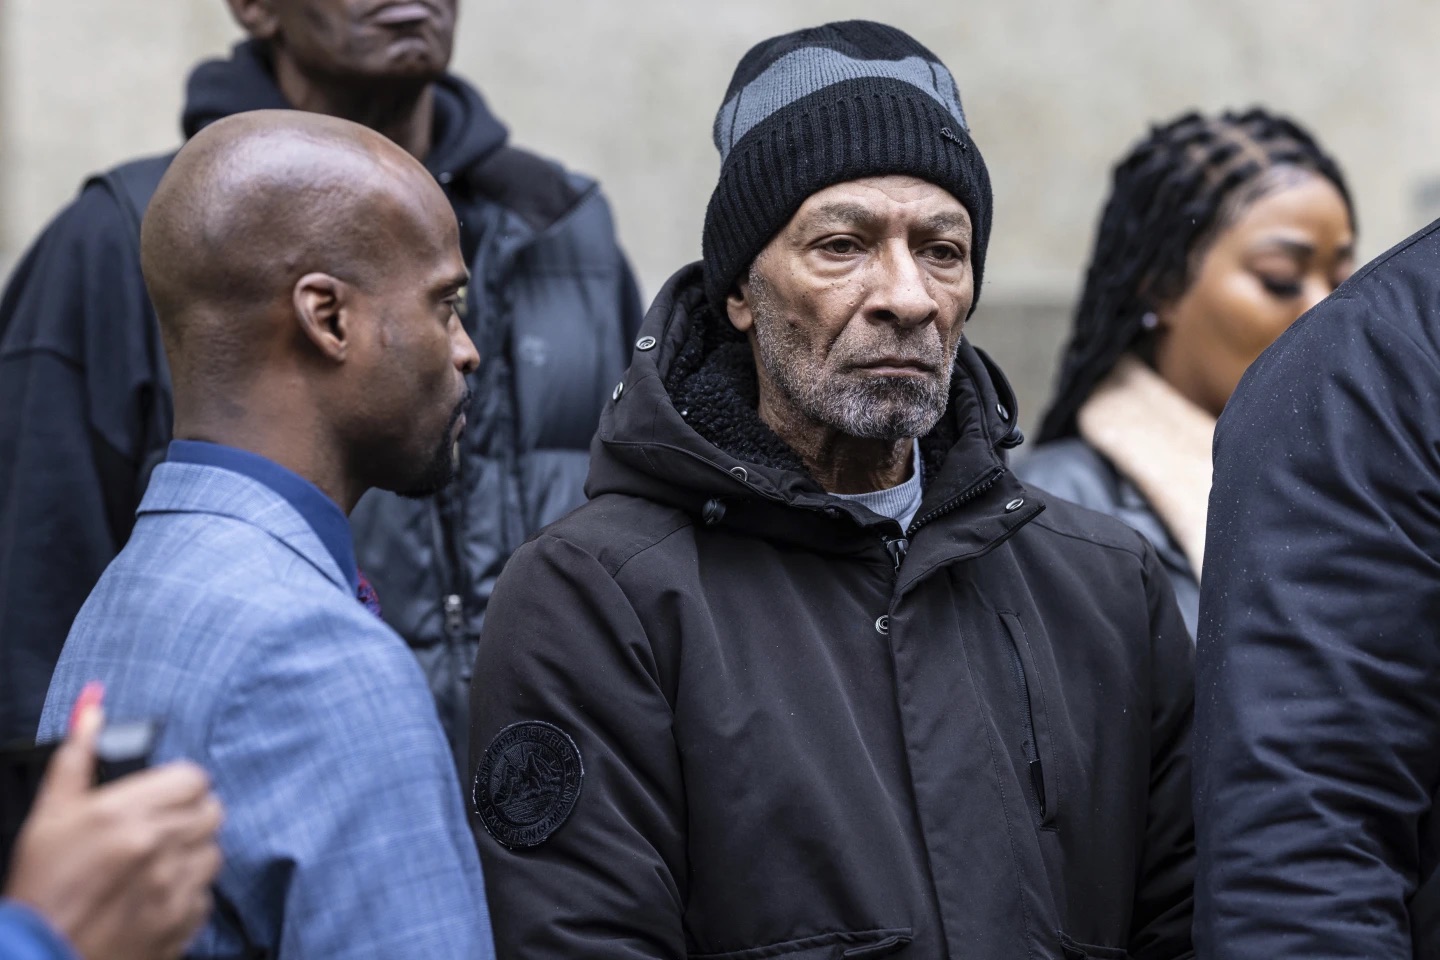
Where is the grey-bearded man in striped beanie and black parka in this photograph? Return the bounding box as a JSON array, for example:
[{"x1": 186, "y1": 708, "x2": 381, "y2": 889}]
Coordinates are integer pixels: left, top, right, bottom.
[{"x1": 471, "y1": 22, "x2": 1192, "y2": 960}]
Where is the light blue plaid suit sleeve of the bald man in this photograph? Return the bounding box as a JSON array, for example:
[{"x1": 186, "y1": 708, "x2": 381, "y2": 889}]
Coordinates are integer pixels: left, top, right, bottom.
[{"x1": 202, "y1": 604, "x2": 492, "y2": 960}]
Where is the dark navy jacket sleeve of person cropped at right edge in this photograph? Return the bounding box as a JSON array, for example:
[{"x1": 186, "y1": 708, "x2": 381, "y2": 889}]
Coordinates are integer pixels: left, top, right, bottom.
[{"x1": 1195, "y1": 298, "x2": 1440, "y2": 960}]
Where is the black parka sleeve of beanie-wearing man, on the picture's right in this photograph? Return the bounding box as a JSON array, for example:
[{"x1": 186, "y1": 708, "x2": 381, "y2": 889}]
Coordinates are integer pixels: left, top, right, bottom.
[{"x1": 1130, "y1": 544, "x2": 1195, "y2": 960}]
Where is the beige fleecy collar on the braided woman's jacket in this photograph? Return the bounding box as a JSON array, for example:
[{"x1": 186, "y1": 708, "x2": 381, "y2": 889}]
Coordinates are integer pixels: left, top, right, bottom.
[{"x1": 1077, "y1": 354, "x2": 1215, "y2": 579}]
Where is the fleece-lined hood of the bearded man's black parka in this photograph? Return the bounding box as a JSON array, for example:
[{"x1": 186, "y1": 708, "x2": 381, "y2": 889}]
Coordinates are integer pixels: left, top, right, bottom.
[{"x1": 586, "y1": 263, "x2": 1038, "y2": 558}]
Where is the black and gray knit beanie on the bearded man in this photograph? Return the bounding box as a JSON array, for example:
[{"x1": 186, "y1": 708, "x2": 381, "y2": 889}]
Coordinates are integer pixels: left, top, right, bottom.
[{"x1": 704, "y1": 20, "x2": 991, "y2": 315}]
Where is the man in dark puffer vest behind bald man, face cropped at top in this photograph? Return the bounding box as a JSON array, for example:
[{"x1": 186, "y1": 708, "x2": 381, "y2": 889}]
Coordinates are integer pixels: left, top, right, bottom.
[{"x1": 0, "y1": 0, "x2": 641, "y2": 764}]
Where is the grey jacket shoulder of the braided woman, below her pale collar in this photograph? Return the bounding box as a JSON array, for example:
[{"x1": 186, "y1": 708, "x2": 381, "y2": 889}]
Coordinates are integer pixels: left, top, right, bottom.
[{"x1": 1015, "y1": 438, "x2": 1200, "y2": 636}]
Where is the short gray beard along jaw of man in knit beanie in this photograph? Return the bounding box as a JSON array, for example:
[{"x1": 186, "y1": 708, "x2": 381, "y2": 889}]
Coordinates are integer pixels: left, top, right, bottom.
[{"x1": 750, "y1": 275, "x2": 955, "y2": 440}]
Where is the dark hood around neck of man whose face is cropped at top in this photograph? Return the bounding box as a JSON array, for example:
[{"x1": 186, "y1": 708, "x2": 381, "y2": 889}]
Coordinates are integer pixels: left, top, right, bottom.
[{"x1": 180, "y1": 40, "x2": 508, "y2": 176}]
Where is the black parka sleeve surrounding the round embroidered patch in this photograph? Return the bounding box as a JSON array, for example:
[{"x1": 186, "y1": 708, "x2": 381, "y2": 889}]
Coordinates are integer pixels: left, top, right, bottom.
[{"x1": 471, "y1": 535, "x2": 685, "y2": 960}]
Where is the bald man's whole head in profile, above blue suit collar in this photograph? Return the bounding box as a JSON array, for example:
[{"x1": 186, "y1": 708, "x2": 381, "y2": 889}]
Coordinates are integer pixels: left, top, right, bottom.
[{"x1": 140, "y1": 111, "x2": 478, "y2": 508}]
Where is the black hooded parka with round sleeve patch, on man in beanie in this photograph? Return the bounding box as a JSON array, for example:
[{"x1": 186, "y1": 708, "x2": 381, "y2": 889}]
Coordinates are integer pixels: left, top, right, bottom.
[{"x1": 471, "y1": 265, "x2": 1192, "y2": 960}]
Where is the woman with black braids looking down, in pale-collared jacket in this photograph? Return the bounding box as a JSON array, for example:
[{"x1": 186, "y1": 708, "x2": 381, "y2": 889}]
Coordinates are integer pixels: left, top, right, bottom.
[{"x1": 1017, "y1": 108, "x2": 1355, "y2": 635}]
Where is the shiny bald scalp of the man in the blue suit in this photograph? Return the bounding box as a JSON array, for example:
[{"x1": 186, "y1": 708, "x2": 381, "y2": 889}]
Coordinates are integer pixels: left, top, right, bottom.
[{"x1": 141, "y1": 111, "x2": 455, "y2": 379}]
